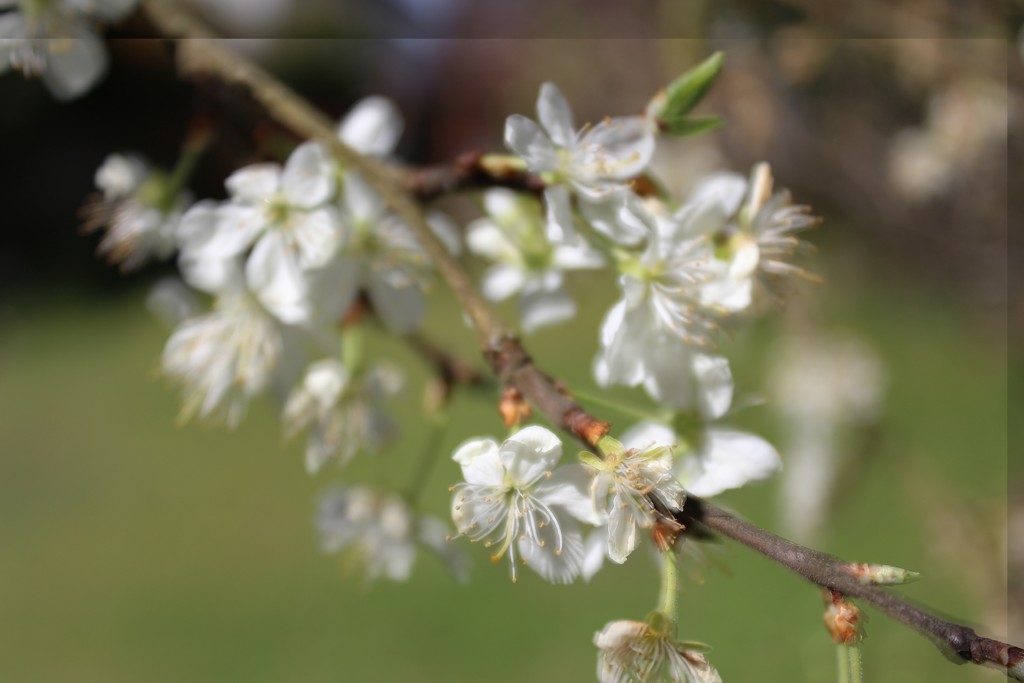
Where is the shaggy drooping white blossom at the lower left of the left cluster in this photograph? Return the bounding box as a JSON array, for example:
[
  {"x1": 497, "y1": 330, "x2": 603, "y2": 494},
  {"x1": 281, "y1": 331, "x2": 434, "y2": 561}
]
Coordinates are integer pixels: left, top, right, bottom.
[{"x1": 162, "y1": 262, "x2": 285, "y2": 427}]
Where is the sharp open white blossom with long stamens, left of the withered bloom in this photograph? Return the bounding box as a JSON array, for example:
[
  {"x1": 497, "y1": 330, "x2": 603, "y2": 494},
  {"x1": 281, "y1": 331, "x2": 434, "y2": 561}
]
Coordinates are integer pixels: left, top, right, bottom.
[{"x1": 452, "y1": 426, "x2": 598, "y2": 584}]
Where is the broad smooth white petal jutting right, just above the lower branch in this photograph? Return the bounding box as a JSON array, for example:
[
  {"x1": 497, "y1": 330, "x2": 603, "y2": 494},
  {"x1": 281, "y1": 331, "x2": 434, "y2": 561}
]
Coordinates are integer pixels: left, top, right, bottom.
[{"x1": 677, "y1": 427, "x2": 782, "y2": 497}]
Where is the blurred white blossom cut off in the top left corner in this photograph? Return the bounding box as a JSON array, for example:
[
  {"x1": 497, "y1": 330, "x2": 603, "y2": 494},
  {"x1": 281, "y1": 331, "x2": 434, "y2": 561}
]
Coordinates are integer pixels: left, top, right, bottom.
[{"x1": 0, "y1": 0, "x2": 137, "y2": 100}]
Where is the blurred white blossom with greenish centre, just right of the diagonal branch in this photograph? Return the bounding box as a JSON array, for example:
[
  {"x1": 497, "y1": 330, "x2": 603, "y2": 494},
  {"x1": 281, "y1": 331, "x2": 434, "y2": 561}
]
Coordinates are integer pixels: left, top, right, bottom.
[{"x1": 466, "y1": 188, "x2": 604, "y2": 332}]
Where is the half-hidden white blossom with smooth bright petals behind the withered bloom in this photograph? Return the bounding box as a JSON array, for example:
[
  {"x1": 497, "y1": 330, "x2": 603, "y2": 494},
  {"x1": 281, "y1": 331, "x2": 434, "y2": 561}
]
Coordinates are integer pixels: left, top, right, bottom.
[{"x1": 623, "y1": 422, "x2": 782, "y2": 498}]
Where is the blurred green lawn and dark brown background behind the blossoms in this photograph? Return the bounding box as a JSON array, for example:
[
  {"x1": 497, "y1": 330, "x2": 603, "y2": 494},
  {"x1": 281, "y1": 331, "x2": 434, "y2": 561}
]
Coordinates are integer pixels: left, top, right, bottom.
[{"x1": 0, "y1": 2, "x2": 1011, "y2": 683}]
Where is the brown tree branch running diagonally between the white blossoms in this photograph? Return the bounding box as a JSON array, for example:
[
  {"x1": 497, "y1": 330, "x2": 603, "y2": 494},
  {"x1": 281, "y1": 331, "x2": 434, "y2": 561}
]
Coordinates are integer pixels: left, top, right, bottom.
[{"x1": 134, "y1": 5, "x2": 1024, "y2": 681}]
